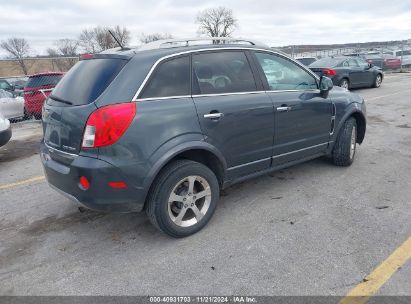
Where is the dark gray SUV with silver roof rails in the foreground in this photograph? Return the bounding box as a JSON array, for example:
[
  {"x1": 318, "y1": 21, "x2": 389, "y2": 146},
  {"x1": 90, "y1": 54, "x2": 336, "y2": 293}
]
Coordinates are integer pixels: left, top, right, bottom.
[{"x1": 41, "y1": 38, "x2": 366, "y2": 237}]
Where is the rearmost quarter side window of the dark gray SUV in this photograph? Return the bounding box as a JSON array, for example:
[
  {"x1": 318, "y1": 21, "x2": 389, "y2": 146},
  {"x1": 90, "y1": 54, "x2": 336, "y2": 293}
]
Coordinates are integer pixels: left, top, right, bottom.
[{"x1": 140, "y1": 56, "x2": 190, "y2": 98}]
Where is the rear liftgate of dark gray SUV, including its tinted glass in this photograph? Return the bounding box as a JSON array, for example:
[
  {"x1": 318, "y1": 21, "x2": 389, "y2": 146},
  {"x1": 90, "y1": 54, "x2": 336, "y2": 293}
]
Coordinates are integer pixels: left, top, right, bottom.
[{"x1": 42, "y1": 58, "x2": 127, "y2": 154}]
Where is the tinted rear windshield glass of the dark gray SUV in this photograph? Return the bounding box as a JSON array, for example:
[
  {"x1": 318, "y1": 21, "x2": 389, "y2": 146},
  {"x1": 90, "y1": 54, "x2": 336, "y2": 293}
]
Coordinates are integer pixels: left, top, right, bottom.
[{"x1": 51, "y1": 58, "x2": 127, "y2": 106}]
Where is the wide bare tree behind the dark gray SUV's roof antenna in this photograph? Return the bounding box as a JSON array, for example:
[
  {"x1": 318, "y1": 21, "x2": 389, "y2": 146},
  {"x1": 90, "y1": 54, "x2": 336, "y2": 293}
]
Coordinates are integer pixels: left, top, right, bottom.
[{"x1": 79, "y1": 25, "x2": 130, "y2": 53}]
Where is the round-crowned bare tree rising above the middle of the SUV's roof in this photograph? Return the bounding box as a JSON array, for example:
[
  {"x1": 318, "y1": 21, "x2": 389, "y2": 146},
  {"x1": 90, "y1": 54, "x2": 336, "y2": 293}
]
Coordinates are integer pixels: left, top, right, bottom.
[{"x1": 196, "y1": 7, "x2": 238, "y2": 37}]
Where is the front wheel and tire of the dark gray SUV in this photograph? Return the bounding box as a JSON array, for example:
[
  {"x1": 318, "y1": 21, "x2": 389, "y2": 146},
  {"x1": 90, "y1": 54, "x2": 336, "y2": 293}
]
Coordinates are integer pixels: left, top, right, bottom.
[{"x1": 332, "y1": 117, "x2": 357, "y2": 167}]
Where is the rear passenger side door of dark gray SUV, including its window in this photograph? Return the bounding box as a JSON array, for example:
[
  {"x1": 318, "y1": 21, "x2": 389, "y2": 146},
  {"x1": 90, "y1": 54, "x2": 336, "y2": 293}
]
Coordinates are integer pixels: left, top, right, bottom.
[{"x1": 192, "y1": 50, "x2": 274, "y2": 178}]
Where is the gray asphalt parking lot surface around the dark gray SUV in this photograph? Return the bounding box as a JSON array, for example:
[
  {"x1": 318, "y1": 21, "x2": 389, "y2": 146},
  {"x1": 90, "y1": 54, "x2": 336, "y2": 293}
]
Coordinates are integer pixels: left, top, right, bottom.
[{"x1": 0, "y1": 74, "x2": 411, "y2": 296}]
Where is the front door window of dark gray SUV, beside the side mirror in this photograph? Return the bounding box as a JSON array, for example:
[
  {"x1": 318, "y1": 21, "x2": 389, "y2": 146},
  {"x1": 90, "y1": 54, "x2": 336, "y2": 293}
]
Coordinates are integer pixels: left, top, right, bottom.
[{"x1": 255, "y1": 52, "x2": 318, "y2": 91}]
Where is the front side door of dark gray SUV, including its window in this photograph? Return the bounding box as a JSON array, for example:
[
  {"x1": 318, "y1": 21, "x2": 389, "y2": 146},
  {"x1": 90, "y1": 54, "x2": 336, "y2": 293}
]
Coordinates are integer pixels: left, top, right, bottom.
[{"x1": 255, "y1": 52, "x2": 332, "y2": 166}]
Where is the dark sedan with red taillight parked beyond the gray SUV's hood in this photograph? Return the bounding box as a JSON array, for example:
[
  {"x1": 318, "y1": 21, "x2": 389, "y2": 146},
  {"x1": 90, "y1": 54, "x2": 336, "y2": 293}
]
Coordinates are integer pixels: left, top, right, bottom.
[{"x1": 309, "y1": 56, "x2": 384, "y2": 89}]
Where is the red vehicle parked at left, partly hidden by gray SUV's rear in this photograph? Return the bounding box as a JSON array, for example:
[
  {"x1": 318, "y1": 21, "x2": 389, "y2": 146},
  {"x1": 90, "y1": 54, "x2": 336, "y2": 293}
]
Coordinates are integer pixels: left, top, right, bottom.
[{"x1": 24, "y1": 72, "x2": 64, "y2": 119}]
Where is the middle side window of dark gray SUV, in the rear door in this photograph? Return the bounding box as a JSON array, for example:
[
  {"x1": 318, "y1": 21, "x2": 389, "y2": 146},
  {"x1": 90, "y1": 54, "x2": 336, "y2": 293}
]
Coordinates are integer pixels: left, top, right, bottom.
[{"x1": 193, "y1": 51, "x2": 257, "y2": 94}]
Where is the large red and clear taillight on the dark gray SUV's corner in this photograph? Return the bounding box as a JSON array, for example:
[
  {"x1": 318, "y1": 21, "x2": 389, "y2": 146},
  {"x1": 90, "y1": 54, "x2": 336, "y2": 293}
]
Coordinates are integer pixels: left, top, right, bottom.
[{"x1": 81, "y1": 102, "x2": 136, "y2": 148}]
